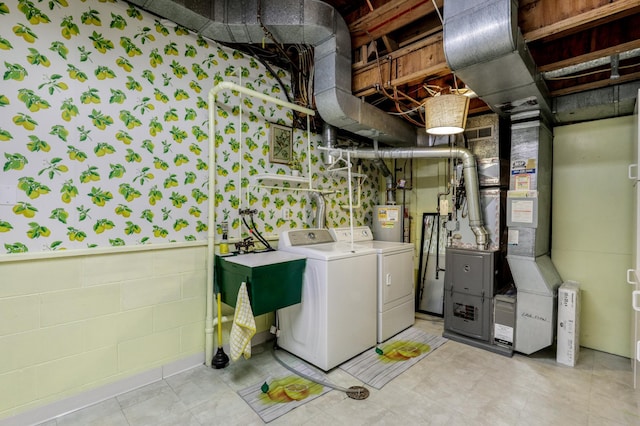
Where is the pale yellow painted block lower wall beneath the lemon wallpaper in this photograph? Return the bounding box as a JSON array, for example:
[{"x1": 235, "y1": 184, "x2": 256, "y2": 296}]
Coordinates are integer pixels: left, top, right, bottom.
[{"x1": 0, "y1": 244, "x2": 208, "y2": 419}]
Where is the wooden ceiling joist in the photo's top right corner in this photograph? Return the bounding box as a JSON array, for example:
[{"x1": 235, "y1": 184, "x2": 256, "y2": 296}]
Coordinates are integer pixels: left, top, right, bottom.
[{"x1": 518, "y1": 0, "x2": 640, "y2": 42}]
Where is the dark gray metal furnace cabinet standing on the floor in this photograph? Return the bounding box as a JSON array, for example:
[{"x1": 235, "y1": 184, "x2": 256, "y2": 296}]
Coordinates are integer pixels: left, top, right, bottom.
[{"x1": 443, "y1": 247, "x2": 513, "y2": 356}]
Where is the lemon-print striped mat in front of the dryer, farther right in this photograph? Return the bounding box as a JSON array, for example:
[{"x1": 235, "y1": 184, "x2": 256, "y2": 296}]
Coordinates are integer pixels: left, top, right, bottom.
[{"x1": 340, "y1": 327, "x2": 447, "y2": 389}]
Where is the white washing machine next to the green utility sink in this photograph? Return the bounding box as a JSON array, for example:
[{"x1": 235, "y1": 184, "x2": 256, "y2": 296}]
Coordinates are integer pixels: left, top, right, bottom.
[{"x1": 277, "y1": 229, "x2": 377, "y2": 371}]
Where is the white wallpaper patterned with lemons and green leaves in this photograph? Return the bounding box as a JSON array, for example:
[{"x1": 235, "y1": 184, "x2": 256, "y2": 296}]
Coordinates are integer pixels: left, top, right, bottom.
[{"x1": 0, "y1": 0, "x2": 378, "y2": 253}]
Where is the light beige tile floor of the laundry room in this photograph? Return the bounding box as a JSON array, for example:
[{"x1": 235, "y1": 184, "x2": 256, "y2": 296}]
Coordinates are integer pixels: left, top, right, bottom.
[{"x1": 37, "y1": 315, "x2": 640, "y2": 426}]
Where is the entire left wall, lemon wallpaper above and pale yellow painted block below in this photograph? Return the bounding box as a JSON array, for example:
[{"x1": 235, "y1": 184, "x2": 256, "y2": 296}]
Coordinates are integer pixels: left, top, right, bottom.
[{"x1": 0, "y1": 0, "x2": 378, "y2": 419}]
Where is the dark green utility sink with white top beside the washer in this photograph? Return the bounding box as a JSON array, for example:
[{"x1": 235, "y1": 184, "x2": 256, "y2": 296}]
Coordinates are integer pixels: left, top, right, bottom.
[{"x1": 214, "y1": 251, "x2": 306, "y2": 316}]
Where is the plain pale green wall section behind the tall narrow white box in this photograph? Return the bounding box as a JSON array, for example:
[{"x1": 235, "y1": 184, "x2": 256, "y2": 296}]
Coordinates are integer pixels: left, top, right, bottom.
[{"x1": 551, "y1": 116, "x2": 637, "y2": 357}]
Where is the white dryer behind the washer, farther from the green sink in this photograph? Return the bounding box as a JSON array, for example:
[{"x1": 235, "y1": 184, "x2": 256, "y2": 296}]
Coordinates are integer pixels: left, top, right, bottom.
[{"x1": 329, "y1": 226, "x2": 415, "y2": 343}]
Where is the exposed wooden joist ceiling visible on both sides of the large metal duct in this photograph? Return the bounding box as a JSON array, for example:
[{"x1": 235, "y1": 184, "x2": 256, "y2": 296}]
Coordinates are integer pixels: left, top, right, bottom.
[{"x1": 320, "y1": 0, "x2": 640, "y2": 123}]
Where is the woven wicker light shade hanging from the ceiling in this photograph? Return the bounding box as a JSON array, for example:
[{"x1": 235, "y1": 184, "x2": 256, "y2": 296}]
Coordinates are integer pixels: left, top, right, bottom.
[{"x1": 425, "y1": 95, "x2": 469, "y2": 135}]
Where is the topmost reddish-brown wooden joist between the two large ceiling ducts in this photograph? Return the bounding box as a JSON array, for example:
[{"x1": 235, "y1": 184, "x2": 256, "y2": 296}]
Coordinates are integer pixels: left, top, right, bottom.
[{"x1": 349, "y1": 0, "x2": 443, "y2": 49}]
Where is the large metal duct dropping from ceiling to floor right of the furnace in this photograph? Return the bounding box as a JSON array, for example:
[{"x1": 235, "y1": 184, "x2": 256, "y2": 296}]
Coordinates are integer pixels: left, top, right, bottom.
[{"x1": 444, "y1": 0, "x2": 561, "y2": 354}]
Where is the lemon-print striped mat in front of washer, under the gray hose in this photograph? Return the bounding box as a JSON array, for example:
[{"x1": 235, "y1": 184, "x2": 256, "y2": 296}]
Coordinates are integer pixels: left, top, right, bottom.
[{"x1": 238, "y1": 363, "x2": 331, "y2": 423}]
